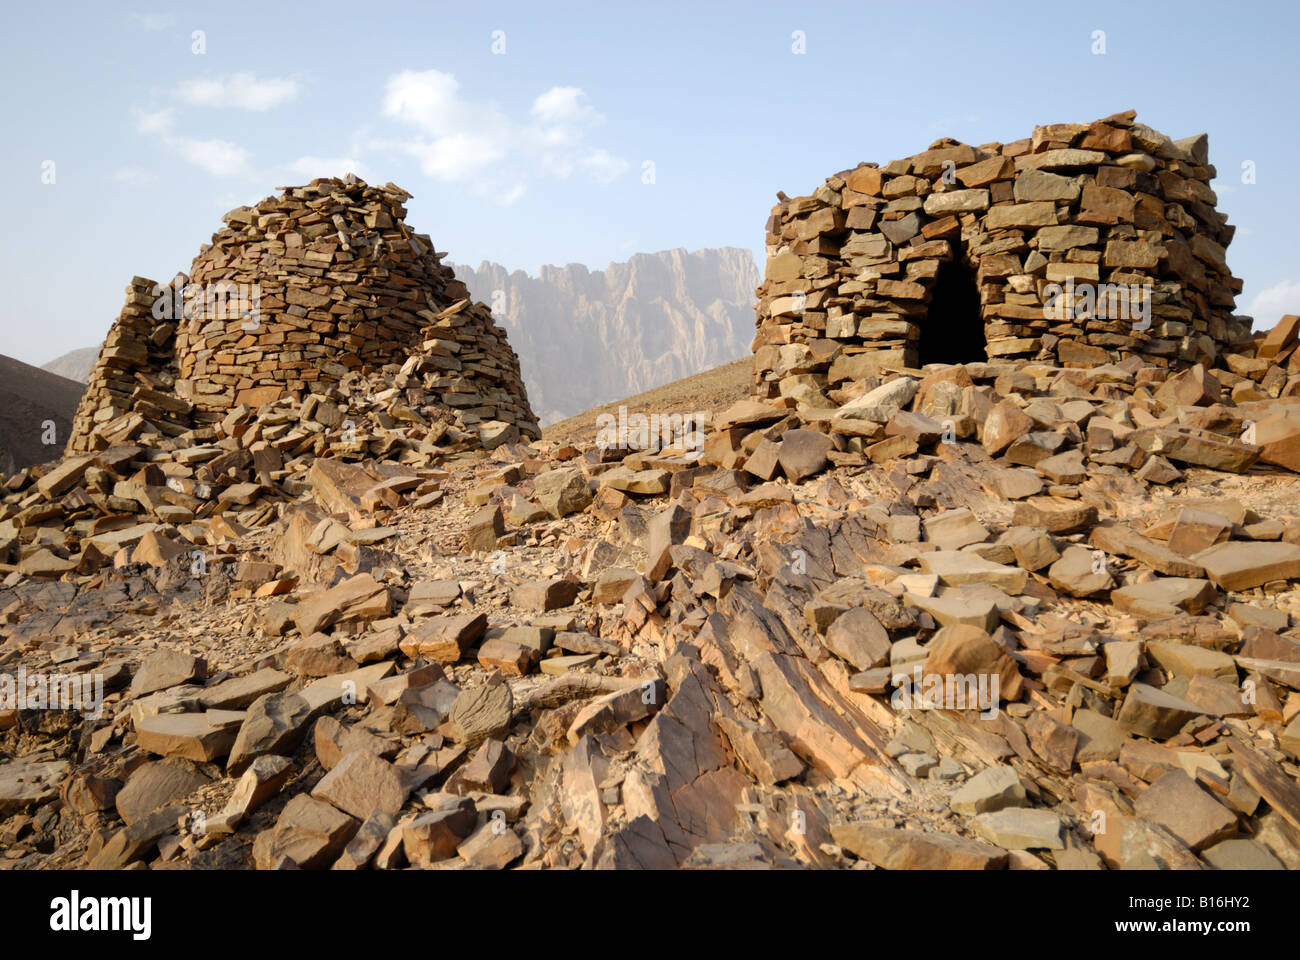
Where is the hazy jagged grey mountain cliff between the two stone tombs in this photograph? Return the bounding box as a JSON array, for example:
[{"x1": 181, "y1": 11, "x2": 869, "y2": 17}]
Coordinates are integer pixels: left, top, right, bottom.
[{"x1": 452, "y1": 247, "x2": 761, "y2": 424}]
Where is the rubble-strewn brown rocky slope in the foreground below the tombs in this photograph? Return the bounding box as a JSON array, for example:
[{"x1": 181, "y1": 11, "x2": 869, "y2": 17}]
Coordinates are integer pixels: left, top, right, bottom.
[{"x1": 0, "y1": 316, "x2": 1300, "y2": 870}]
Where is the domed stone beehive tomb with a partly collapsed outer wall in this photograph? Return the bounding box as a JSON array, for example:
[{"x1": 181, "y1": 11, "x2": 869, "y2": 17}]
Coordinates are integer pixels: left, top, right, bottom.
[{"x1": 68, "y1": 176, "x2": 541, "y2": 453}]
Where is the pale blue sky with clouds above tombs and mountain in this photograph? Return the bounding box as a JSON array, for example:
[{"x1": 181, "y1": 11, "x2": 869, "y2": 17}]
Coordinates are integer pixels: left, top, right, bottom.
[{"x1": 0, "y1": 0, "x2": 1300, "y2": 364}]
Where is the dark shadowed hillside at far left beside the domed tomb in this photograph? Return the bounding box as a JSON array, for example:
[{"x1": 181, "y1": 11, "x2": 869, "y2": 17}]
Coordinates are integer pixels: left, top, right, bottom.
[{"x1": 0, "y1": 356, "x2": 83, "y2": 473}]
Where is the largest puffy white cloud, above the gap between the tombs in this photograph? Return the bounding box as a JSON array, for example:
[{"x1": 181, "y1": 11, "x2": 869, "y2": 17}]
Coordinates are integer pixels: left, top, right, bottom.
[{"x1": 368, "y1": 70, "x2": 628, "y2": 206}]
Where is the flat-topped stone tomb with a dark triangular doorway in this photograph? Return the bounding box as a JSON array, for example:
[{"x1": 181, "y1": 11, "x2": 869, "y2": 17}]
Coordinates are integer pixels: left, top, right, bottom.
[{"x1": 754, "y1": 112, "x2": 1251, "y2": 405}]
